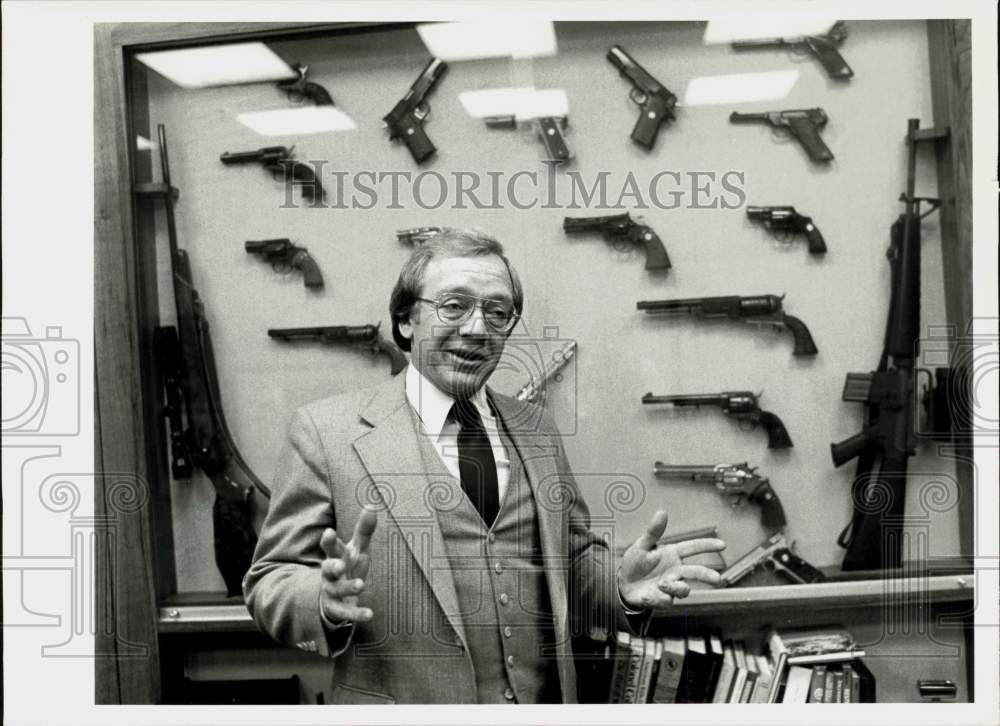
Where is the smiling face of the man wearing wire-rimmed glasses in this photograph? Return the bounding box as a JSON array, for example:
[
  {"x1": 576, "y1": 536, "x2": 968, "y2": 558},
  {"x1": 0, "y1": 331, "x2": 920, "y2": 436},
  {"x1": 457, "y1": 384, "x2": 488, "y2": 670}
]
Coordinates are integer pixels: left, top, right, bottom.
[{"x1": 399, "y1": 255, "x2": 514, "y2": 398}]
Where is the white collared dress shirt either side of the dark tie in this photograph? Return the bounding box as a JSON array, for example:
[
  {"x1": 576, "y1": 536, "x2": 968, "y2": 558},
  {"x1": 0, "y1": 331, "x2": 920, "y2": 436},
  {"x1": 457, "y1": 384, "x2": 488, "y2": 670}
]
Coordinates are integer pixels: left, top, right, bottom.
[{"x1": 406, "y1": 363, "x2": 510, "y2": 502}]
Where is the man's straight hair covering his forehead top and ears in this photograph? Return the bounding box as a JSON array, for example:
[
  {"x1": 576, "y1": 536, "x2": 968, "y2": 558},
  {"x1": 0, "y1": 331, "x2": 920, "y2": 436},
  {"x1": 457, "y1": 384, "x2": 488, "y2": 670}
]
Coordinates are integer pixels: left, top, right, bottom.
[{"x1": 389, "y1": 227, "x2": 524, "y2": 351}]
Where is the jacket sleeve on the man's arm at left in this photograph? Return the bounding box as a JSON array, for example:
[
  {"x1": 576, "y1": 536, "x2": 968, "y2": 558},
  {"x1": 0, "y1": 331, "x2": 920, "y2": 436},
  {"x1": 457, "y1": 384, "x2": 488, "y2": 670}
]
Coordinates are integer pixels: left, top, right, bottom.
[{"x1": 243, "y1": 409, "x2": 354, "y2": 656}]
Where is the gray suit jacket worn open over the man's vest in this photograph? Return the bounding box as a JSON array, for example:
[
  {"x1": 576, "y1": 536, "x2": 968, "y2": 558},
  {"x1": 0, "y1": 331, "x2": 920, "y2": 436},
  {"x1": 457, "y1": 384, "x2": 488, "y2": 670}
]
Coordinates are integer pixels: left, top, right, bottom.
[{"x1": 243, "y1": 375, "x2": 628, "y2": 703}]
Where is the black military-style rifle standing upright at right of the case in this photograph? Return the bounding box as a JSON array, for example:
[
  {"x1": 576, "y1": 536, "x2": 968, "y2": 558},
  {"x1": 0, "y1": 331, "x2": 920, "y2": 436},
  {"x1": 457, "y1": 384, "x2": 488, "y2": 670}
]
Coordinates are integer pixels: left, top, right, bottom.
[{"x1": 830, "y1": 119, "x2": 947, "y2": 570}]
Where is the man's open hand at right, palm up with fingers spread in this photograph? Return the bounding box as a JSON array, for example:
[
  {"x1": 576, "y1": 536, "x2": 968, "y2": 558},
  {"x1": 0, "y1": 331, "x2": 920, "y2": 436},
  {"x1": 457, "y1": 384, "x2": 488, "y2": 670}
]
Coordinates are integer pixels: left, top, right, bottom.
[{"x1": 618, "y1": 509, "x2": 726, "y2": 610}]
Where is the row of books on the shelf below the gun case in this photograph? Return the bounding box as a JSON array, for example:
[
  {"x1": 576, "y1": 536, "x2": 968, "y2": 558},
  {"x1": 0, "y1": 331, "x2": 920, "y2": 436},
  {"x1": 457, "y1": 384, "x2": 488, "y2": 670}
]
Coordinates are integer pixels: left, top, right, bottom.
[{"x1": 608, "y1": 626, "x2": 875, "y2": 703}]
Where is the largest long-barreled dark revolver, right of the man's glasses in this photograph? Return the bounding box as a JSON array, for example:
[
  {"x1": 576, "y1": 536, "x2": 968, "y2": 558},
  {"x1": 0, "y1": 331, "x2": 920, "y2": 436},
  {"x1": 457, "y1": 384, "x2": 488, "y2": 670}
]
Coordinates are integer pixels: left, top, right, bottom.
[{"x1": 636, "y1": 295, "x2": 817, "y2": 355}]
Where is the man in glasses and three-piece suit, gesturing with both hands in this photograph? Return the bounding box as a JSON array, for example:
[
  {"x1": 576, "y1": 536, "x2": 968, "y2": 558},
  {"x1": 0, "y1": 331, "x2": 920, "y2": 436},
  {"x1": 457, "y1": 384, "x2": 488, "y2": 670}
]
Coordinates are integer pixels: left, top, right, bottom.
[{"x1": 243, "y1": 230, "x2": 725, "y2": 704}]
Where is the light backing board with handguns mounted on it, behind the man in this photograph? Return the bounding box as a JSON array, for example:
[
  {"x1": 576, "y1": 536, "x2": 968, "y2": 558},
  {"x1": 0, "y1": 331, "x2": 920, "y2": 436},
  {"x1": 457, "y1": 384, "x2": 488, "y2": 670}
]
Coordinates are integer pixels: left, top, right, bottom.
[{"x1": 131, "y1": 20, "x2": 958, "y2": 591}]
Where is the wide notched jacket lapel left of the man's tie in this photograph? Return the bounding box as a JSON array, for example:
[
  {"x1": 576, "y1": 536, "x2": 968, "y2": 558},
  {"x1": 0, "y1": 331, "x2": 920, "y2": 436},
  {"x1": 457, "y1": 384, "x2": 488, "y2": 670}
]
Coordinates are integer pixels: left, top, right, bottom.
[{"x1": 354, "y1": 374, "x2": 466, "y2": 642}]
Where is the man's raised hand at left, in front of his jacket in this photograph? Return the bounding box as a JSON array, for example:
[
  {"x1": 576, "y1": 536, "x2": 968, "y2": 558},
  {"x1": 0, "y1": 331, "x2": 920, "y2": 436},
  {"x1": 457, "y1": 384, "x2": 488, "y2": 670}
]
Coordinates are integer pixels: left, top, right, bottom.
[{"x1": 319, "y1": 509, "x2": 378, "y2": 624}]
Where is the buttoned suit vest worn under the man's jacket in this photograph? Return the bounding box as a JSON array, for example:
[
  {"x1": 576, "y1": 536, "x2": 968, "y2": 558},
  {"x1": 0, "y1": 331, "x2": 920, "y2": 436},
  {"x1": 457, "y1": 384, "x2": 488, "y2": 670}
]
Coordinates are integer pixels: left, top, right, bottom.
[{"x1": 408, "y1": 404, "x2": 562, "y2": 703}]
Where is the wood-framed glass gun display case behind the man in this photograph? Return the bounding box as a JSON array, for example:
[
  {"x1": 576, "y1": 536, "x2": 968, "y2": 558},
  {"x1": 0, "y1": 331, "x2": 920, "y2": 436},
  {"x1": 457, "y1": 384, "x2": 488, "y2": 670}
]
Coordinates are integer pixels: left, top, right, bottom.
[{"x1": 97, "y1": 18, "x2": 974, "y2": 702}]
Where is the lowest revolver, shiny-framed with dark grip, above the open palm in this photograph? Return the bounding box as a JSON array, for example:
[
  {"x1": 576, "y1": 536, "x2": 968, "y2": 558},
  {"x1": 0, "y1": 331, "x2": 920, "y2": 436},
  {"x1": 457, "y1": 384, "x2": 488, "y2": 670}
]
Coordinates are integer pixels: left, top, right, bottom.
[{"x1": 653, "y1": 461, "x2": 788, "y2": 532}]
